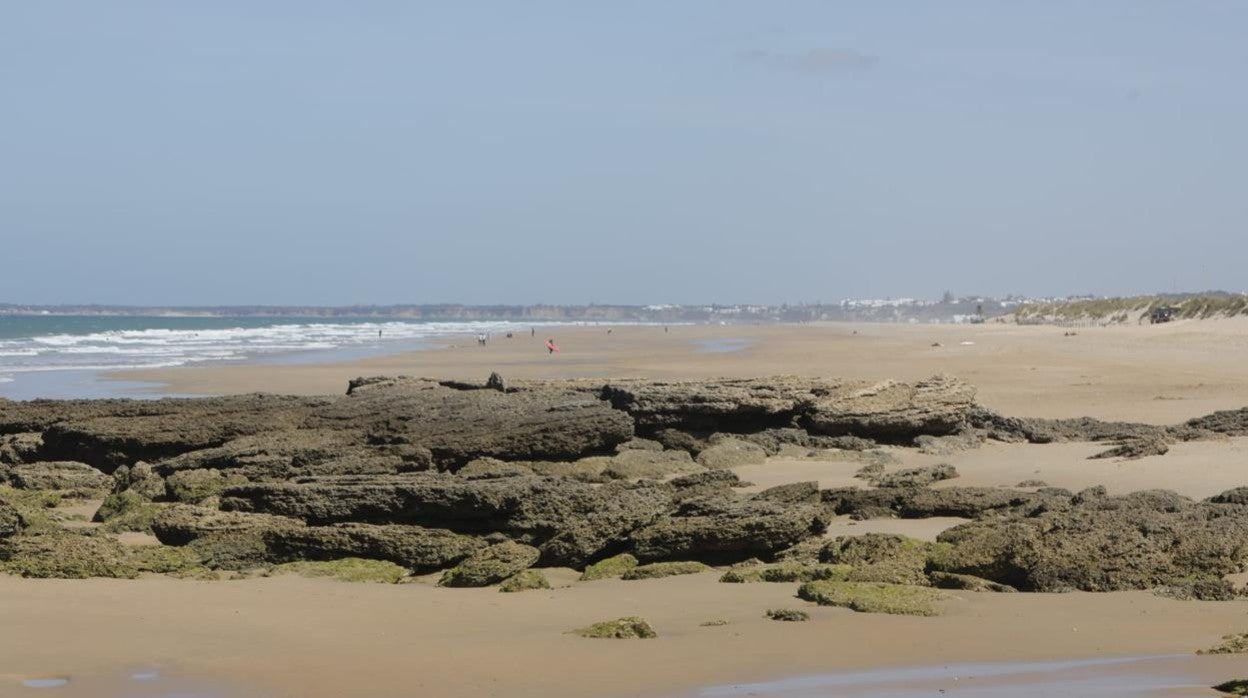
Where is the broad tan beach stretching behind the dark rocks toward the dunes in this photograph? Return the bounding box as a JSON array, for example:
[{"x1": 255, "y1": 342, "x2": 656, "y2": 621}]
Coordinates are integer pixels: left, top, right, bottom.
[{"x1": 109, "y1": 318, "x2": 1248, "y2": 425}]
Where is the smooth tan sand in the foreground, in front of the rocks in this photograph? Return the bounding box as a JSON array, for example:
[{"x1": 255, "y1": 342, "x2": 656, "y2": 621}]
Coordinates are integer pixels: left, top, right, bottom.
[{"x1": 7, "y1": 573, "x2": 1248, "y2": 698}]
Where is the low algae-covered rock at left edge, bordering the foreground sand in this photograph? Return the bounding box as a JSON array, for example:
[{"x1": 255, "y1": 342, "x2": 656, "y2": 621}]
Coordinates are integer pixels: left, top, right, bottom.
[{"x1": 0, "y1": 531, "x2": 140, "y2": 579}]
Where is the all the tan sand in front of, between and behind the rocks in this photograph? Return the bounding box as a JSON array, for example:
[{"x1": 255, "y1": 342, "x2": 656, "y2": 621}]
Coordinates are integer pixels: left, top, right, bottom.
[{"x1": 9, "y1": 321, "x2": 1248, "y2": 697}]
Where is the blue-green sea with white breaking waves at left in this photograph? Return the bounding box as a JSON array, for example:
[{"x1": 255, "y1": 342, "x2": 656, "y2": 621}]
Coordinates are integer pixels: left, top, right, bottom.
[{"x1": 0, "y1": 315, "x2": 529, "y2": 400}]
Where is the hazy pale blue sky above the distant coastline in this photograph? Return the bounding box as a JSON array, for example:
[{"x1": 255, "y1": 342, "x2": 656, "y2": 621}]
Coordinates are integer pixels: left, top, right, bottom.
[{"x1": 0, "y1": 0, "x2": 1248, "y2": 305}]
